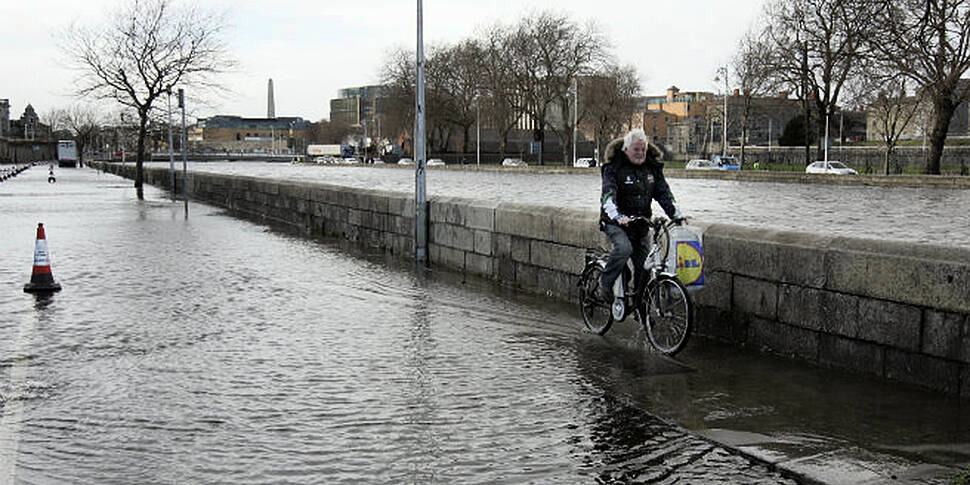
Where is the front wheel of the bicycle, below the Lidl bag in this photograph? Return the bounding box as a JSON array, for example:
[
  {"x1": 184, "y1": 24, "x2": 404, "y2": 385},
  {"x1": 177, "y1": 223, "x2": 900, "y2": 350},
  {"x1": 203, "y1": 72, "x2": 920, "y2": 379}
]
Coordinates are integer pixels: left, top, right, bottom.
[{"x1": 637, "y1": 275, "x2": 694, "y2": 355}]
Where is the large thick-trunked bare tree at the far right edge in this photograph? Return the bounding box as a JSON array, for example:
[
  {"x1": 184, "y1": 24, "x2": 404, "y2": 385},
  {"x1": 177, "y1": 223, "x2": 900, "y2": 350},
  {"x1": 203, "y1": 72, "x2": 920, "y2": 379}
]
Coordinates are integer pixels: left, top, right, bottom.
[{"x1": 871, "y1": 0, "x2": 970, "y2": 174}]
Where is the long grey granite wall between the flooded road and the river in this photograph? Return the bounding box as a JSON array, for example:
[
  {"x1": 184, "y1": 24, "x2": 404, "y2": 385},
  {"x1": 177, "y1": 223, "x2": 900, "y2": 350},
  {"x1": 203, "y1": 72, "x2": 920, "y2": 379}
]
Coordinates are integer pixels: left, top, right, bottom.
[{"x1": 92, "y1": 164, "x2": 970, "y2": 398}]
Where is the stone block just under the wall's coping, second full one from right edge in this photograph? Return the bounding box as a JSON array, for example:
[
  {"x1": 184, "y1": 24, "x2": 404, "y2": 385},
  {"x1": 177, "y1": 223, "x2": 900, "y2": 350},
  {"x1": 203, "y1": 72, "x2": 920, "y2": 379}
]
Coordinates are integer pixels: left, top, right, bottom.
[{"x1": 859, "y1": 298, "x2": 923, "y2": 352}]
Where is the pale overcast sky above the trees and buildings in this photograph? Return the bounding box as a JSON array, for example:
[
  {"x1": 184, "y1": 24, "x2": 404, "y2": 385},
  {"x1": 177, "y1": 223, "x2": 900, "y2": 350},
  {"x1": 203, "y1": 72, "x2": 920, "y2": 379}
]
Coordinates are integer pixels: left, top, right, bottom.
[{"x1": 0, "y1": 0, "x2": 764, "y2": 121}]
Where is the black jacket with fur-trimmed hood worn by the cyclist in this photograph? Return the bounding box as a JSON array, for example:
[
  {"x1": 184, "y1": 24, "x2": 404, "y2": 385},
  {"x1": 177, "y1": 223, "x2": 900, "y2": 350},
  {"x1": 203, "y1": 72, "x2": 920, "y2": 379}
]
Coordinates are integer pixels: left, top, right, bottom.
[{"x1": 600, "y1": 138, "x2": 679, "y2": 229}]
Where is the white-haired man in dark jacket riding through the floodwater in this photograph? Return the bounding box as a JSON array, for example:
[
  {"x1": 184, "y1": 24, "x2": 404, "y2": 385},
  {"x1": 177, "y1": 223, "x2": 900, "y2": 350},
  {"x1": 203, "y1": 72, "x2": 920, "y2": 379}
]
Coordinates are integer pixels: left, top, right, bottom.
[{"x1": 600, "y1": 128, "x2": 686, "y2": 301}]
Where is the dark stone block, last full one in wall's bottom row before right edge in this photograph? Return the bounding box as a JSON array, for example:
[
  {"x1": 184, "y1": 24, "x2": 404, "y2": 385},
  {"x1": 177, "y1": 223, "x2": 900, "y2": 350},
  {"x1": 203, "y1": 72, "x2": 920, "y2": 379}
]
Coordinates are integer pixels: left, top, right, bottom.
[{"x1": 886, "y1": 349, "x2": 961, "y2": 395}]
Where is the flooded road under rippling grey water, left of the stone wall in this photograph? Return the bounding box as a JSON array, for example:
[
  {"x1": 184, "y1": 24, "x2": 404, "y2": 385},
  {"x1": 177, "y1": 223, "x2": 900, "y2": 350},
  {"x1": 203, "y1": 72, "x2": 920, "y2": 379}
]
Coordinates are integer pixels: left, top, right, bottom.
[{"x1": 0, "y1": 167, "x2": 970, "y2": 484}]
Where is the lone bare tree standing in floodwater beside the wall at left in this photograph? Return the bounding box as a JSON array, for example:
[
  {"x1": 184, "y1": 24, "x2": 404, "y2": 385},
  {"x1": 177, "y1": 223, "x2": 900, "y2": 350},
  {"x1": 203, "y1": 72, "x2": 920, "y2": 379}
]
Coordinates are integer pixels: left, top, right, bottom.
[{"x1": 62, "y1": 0, "x2": 233, "y2": 197}]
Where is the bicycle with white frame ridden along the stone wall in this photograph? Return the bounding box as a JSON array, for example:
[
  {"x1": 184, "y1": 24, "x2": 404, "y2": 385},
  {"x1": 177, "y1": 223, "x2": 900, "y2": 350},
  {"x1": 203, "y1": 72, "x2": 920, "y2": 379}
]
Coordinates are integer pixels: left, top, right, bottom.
[{"x1": 578, "y1": 216, "x2": 694, "y2": 355}]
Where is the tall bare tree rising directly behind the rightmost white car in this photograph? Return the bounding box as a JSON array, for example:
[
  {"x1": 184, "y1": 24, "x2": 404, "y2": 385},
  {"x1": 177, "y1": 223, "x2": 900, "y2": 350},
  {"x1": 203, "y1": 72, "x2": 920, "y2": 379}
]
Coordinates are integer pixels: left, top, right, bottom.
[{"x1": 766, "y1": 0, "x2": 877, "y2": 163}]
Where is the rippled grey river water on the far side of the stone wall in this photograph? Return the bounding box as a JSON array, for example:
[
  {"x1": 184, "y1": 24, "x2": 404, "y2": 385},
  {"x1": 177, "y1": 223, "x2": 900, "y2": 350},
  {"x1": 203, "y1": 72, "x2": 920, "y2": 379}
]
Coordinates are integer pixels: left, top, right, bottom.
[{"x1": 168, "y1": 162, "x2": 970, "y2": 248}]
